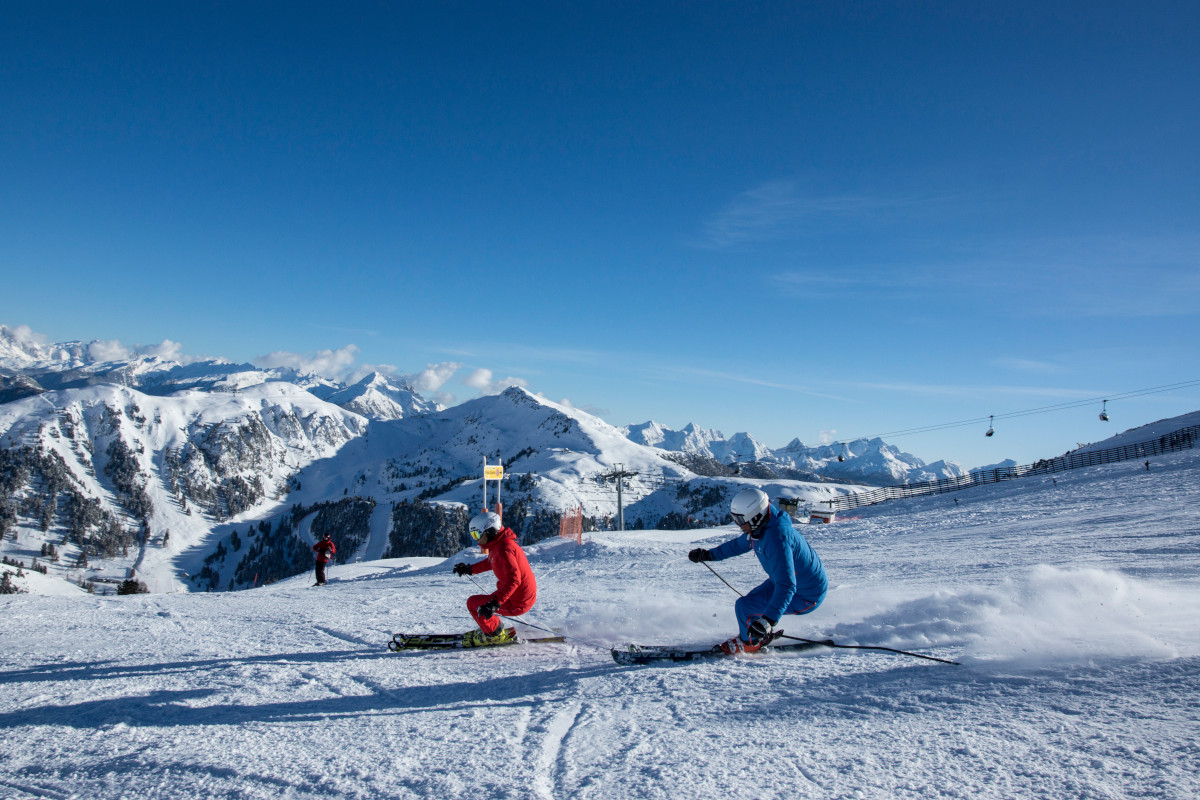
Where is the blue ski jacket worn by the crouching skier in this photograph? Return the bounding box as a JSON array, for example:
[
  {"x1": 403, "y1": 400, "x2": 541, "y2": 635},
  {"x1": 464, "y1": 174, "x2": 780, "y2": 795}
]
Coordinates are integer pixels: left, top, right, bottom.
[{"x1": 709, "y1": 506, "x2": 829, "y2": 621}]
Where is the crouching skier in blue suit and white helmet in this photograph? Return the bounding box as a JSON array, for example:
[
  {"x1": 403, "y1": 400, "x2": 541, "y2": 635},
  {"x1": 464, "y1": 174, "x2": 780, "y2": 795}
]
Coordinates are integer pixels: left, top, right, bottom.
[{"x1": 688, "y1": 488, "x2": 829, "y2": 655}]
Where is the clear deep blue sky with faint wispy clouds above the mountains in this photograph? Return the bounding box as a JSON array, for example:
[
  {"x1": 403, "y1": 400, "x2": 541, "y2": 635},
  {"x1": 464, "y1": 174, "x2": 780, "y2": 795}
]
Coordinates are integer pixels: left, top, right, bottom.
[{"x1": 0, "y1": 2, "x2": 1200, "y2": 467}]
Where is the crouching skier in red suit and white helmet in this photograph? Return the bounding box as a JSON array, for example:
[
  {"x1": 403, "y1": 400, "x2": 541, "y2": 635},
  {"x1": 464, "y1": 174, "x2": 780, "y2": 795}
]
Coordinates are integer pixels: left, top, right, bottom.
[{"x1": 454, "y1": 511, "x2": 538, "y2": 644}]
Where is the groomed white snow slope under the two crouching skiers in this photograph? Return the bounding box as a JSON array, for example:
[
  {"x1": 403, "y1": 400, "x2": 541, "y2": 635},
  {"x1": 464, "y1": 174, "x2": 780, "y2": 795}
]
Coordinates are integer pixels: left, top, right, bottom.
[{"x1": 0, "y1": 451, "x2": 1200, "y2": 800}]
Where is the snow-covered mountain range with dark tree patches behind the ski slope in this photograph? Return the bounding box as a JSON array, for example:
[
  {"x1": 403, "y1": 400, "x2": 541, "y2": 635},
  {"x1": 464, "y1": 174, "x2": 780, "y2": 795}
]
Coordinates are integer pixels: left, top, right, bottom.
[{"x1": 0, "y1": 326, "x2": 1041, "y2": 590}]
